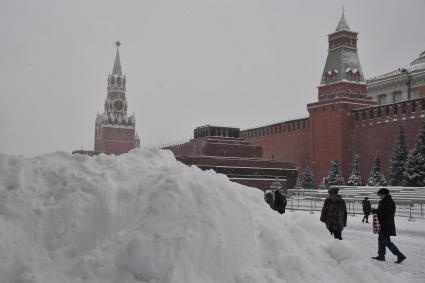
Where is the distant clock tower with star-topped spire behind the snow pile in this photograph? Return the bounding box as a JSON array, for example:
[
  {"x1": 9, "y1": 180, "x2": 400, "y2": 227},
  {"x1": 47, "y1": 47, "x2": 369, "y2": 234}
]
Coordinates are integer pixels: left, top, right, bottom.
[{"x1": 94, "y1": 41, "x2": 140, "y2": 155}]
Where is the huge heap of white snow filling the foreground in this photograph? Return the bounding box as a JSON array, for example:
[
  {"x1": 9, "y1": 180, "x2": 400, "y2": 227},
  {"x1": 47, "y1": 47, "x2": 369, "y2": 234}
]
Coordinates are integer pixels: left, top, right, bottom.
[{"x1": 0, "y1": 150, "x2": 410, "y2": 283}]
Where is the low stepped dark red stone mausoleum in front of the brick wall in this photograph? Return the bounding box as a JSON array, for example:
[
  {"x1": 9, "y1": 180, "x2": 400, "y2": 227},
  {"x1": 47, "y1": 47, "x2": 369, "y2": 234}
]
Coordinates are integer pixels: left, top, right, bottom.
[{"x1": 164, "y1": 125, "x2": 297, "y2": 190}]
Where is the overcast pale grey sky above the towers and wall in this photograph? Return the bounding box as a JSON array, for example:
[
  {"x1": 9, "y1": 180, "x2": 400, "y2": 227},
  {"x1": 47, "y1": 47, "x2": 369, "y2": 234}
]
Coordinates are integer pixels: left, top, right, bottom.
[{"x1": 0, "y1": 0, "x2": 425, "y2": 156}]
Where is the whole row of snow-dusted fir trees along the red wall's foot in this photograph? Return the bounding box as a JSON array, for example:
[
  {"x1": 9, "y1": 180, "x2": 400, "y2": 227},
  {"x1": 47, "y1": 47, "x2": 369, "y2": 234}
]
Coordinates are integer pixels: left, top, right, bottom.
[{"x1": 301, "y1": 120, "x2": 425, "y2": 189}]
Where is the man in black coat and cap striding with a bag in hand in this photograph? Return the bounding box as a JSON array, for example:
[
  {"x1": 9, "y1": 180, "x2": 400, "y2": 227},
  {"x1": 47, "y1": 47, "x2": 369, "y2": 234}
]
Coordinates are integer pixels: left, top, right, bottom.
[{"x1": 372, "y1": 189, "x2": 406, "y2": 263}]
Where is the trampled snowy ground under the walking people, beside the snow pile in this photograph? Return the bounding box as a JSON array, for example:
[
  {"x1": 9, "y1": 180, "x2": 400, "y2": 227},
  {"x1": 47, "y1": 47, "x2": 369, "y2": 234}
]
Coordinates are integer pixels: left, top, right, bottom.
[{"x1": 296, "y1": 211, "x2": 425, "y2": 283}]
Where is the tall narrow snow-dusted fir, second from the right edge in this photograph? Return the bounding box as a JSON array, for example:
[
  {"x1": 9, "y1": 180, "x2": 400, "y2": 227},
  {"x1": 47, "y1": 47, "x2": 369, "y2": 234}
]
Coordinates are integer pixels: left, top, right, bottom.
[{"x1": 388, "y1": 124, "x2": 409, "y2": 186}]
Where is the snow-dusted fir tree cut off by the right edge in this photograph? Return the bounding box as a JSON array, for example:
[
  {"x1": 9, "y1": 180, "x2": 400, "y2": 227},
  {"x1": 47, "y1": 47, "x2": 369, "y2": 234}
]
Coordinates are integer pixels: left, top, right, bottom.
[{"x1": 403, "y1": 120, "x2": 425, "y2": 187}]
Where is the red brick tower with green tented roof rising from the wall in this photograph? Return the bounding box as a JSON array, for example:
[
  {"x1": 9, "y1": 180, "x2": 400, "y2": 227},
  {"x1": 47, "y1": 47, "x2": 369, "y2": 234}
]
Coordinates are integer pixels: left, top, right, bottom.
[{"x1": 307, "y1": 12, "x2": 375, "y2": 186}]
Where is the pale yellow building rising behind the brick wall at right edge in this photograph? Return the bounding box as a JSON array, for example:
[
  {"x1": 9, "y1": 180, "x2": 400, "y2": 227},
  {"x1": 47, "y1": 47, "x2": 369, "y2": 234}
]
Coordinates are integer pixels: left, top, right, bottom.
[{"x1": 367, "y1": 51, "x2": 425, "y2": 104}]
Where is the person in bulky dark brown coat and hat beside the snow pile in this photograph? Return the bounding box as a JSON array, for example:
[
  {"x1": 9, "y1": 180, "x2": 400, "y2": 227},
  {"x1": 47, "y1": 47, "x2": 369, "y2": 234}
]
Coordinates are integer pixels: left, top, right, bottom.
[{"x1": 320, "y1": 188, "x2": 347, "y2": 240}]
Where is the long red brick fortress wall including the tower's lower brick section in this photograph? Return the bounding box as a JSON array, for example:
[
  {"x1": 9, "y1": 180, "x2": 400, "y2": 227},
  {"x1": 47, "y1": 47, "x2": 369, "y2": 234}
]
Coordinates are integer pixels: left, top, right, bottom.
[{"x1": 241, "y1": 98, "x2": 425, "y2": 189}]
